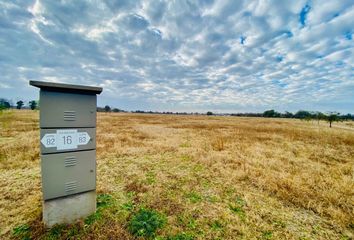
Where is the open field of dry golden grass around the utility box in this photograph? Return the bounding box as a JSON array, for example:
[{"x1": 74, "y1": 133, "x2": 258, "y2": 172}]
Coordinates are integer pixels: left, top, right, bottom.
[{"x1": 0, "y1": 110, "x2": 354, "y2": 239}]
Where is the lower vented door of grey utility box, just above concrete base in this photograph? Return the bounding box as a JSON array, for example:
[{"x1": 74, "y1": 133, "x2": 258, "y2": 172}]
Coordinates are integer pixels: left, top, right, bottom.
[{"x1": 41, "y1": 150, "x2": 96, "y2": 200}]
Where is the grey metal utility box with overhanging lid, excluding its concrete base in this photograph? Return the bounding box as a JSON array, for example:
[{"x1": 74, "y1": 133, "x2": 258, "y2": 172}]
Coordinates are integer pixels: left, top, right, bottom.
[{"x1": 30, "y1": 81, "x2": 102, "y2": 227}]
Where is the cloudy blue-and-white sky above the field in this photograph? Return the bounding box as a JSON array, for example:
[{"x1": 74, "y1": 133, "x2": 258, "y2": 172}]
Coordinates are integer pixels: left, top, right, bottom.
[{"x1": 0, "y1": 0, "x2": 354, "y2": 113}]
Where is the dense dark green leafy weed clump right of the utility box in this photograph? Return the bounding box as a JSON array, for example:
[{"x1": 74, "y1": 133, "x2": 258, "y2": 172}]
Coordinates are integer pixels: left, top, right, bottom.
[{"x1": 128, "y1": 208, "x2": 166, "y2": 238}]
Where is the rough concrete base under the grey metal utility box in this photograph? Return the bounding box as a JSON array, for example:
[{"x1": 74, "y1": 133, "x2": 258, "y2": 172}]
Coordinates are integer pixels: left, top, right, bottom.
[{"x1": 43, "y1": 191, "x2": 96, "y2": 227}]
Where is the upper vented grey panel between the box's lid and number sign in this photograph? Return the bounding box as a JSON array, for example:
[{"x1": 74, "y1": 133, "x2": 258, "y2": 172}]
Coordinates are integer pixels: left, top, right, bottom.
[{"x1": 40, "y1": 90, "x2": 97, "y2": 128}]
